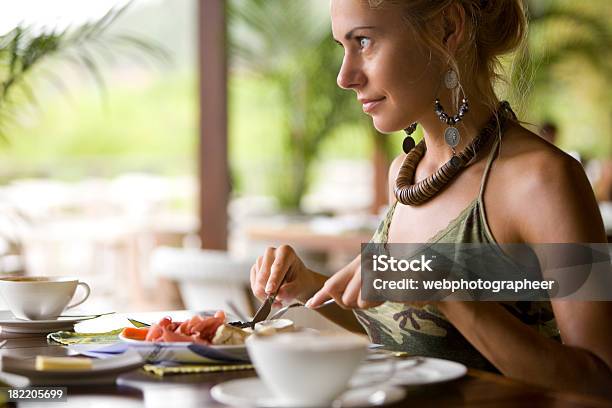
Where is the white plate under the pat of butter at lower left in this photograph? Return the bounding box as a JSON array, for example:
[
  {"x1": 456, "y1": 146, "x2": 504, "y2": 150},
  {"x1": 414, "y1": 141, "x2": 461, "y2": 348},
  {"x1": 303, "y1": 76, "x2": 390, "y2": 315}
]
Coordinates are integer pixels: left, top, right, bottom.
[{"x1": 2, "y1": 350, "x2": 145, "y2": 385}]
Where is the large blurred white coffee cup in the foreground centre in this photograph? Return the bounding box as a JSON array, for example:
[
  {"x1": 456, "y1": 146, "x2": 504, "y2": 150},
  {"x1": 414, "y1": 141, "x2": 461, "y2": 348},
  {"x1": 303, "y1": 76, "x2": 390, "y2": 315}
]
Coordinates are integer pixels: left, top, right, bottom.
[{"x1": 246, "y1": 332, "x2": 368, "y2": 407}]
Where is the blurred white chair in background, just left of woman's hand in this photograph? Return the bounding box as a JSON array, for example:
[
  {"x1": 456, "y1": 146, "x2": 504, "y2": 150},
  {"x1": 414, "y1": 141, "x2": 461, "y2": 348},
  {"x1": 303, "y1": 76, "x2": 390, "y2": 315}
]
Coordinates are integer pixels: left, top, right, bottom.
[{"x1": 150, "y1": 247, "x2": 253, "y2": 314}]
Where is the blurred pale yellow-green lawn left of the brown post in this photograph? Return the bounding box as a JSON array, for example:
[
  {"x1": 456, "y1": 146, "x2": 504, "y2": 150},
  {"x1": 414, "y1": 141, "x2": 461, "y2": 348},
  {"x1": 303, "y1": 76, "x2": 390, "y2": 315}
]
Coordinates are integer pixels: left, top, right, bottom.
[{"x1": 0, "y1": 72, "x2": 198, "y2": 179}]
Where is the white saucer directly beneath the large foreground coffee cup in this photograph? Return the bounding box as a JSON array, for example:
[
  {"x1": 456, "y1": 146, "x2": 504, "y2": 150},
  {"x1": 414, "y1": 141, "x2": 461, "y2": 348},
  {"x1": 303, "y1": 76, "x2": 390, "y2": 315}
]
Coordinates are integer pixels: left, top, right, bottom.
[{"x1": 210, "y1": 377, "x2": 406, "y2": 408}]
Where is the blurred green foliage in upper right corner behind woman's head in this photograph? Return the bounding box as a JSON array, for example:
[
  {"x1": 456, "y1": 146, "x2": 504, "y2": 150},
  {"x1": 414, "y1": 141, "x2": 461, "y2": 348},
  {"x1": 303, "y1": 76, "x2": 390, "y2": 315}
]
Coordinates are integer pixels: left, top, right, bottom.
[{"x1": 510, "y1": 0, "x2": 612, "y2": 157}]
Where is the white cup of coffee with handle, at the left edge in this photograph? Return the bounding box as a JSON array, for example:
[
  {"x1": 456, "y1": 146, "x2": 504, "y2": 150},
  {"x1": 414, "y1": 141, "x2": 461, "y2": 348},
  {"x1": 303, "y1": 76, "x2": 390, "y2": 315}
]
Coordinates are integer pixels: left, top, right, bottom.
[{"x1": 0, "y1": 276, "x2": 91, "y2": 320}]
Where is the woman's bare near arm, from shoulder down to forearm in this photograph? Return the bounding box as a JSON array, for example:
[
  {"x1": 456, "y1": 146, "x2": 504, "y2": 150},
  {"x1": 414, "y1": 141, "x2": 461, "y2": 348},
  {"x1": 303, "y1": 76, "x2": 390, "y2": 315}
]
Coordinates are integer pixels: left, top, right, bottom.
[{"x1": 438, "y1": 152, "x2": 612, "y2": 393}]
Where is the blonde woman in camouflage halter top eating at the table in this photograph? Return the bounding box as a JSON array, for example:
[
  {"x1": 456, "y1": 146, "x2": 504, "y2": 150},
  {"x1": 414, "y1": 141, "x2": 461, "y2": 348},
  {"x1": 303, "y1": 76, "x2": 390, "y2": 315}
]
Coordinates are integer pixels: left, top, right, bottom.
[{"x1": 251, "y1": 0, "x2": 612, "y2": 391}]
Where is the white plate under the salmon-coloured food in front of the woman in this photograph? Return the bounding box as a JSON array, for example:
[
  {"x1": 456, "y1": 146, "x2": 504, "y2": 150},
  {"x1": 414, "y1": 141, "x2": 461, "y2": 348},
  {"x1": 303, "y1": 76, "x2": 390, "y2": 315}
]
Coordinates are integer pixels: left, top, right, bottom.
[{"x1": 119, "y1": 334, "x2": 249, "y2": 363}]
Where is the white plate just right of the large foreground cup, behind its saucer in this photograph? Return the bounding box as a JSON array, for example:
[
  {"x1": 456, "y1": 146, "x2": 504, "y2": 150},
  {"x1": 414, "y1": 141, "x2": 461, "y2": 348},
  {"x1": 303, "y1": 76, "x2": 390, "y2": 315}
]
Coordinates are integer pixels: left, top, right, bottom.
[{"x1": 351, "y1": 357, "x2": 467, "y2": 387}]
